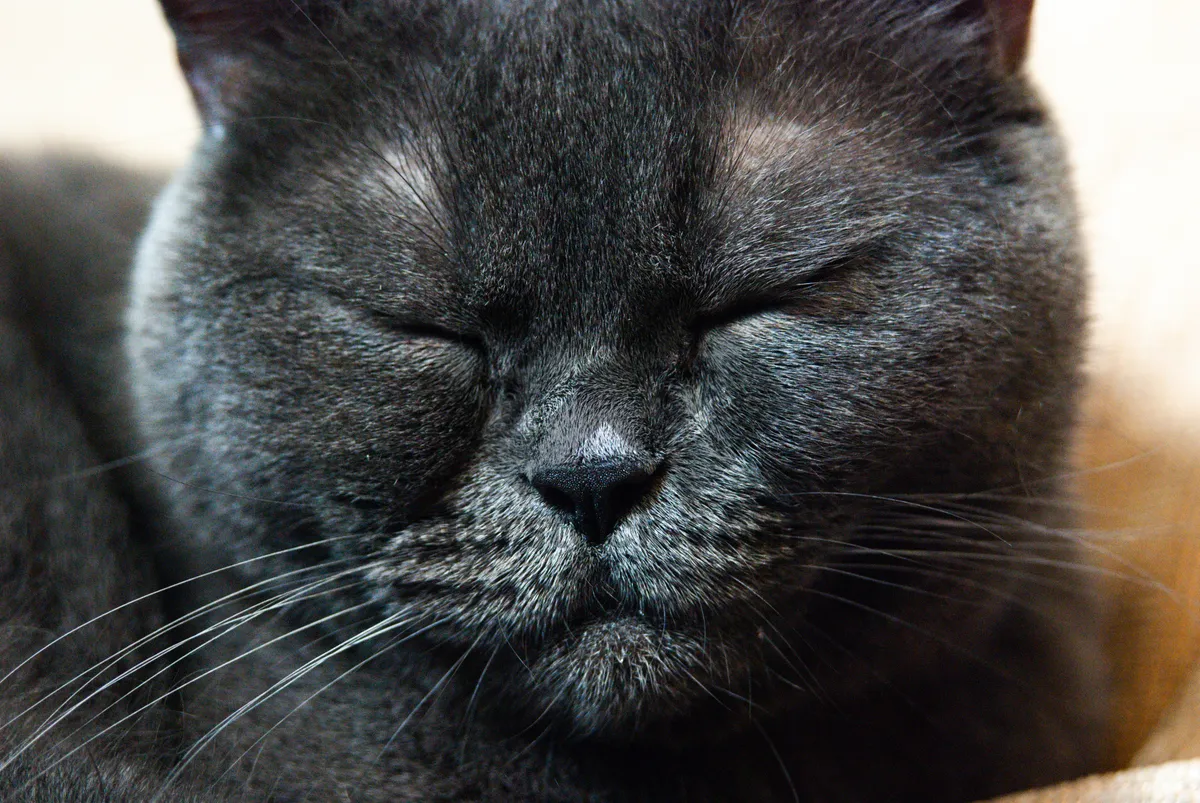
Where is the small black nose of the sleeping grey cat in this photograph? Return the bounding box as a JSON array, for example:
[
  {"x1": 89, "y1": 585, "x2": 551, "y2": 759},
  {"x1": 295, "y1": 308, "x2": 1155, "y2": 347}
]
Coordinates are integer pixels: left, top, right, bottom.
[{"x1": 529, "y1": 460, "x2": 654, "y2": 544}]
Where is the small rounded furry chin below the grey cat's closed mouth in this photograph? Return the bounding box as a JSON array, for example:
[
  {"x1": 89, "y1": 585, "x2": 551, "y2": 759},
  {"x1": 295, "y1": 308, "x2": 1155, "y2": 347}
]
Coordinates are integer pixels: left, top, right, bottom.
[{"x1": 529, "y1": 616, "x2": 713, "y2": 737}]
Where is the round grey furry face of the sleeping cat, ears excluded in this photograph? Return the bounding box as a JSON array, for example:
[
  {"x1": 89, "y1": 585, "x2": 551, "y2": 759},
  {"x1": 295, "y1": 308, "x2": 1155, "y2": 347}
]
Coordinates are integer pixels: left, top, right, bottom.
[{"x1": 131, "y1": 2, "x2": 1079, "y2": 732}]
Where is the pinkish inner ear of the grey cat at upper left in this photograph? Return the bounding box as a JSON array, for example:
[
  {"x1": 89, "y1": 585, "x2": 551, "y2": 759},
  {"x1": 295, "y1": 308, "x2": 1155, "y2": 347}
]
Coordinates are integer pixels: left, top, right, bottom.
[{"x1": 161, "y1": 0, "x2": 314, "y2": 125}]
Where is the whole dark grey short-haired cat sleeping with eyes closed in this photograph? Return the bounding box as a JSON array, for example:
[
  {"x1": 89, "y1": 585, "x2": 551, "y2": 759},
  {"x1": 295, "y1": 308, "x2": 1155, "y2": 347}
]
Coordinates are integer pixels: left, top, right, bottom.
[{"x1": 0, "y1": 0, "x2": 1105, "y2": 803}]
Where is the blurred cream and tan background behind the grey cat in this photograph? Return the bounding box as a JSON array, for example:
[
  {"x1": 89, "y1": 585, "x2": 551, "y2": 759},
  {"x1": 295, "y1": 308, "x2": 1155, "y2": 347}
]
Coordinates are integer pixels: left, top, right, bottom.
[{"x1": 0, "y1": 0, "x2": 1200, "y2": 761}]
